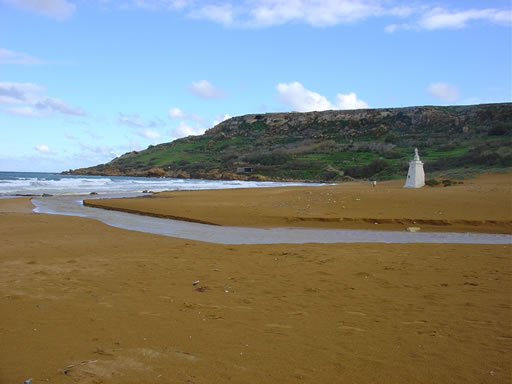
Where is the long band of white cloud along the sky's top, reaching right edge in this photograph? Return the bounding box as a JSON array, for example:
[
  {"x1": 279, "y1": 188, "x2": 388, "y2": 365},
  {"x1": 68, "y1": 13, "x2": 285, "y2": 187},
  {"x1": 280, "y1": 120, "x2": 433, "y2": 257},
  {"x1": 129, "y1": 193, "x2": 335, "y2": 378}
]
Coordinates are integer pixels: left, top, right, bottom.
[{"x1": 97, "y1": 0, "x2": 512, "y2": 33}]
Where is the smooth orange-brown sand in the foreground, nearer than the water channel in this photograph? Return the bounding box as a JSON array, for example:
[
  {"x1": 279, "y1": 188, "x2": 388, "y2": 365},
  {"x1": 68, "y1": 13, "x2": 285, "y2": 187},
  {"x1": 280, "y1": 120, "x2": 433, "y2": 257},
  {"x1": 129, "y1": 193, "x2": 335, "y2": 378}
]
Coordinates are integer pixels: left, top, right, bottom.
[{"x1": 0, "y1": 173, "x2": 512, "y2": 384}]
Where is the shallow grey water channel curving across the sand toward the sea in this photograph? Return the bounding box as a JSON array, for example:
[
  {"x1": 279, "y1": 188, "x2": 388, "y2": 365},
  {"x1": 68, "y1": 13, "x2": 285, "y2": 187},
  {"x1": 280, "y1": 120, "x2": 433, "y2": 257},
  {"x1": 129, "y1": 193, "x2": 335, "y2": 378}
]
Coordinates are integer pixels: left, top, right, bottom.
[{"x1": 32, "y1": 194, "x2": 512, "y2": 244}]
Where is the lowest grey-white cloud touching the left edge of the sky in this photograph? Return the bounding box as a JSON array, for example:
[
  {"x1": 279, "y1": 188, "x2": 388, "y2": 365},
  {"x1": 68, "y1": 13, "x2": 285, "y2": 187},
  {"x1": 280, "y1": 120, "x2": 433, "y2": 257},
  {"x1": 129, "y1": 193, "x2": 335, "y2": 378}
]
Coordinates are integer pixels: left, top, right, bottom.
[{"x1": 0, "y1": 82, "x2": 85, "y2": 117}]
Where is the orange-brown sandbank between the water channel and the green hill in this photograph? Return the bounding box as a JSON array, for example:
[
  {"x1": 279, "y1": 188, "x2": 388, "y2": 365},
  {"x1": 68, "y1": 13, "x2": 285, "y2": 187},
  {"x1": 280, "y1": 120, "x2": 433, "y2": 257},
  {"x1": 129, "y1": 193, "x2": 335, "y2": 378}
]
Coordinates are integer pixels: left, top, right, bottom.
[{"x1": 85, "y1": 172, "x2": 512, "y2": 234}]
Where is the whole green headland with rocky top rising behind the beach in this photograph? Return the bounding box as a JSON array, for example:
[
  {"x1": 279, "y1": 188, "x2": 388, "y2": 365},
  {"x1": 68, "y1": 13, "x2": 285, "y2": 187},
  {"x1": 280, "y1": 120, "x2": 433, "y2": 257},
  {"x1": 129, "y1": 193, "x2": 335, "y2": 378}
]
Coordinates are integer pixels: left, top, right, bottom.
[{"x1": 66, "y1": 103, "x2": 512, "y2": 181}]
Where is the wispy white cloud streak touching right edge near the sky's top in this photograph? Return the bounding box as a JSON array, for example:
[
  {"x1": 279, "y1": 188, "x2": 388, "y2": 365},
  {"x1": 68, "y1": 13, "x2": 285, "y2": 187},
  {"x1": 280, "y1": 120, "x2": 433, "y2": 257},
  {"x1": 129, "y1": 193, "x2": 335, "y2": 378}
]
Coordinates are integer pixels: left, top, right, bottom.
[{"x1": 418, "y1": 8, "x2": 512, "y2": 30}]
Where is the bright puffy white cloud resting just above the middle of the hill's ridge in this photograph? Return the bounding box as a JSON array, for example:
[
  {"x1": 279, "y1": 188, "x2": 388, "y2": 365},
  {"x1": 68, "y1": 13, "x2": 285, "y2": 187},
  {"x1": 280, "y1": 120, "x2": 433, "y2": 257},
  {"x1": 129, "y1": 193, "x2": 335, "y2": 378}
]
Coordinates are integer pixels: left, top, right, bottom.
[{"x1": 277, "y1": 81, "x2": 369, "y2": 112}]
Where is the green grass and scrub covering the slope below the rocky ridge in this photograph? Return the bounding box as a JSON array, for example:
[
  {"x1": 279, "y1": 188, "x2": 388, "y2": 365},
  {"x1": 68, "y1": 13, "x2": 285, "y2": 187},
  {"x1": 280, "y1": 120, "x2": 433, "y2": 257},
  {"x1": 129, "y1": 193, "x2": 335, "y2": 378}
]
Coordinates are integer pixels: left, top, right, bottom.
[{"x1": 76, "y1": 105, "x2": 512, "y2": 180}]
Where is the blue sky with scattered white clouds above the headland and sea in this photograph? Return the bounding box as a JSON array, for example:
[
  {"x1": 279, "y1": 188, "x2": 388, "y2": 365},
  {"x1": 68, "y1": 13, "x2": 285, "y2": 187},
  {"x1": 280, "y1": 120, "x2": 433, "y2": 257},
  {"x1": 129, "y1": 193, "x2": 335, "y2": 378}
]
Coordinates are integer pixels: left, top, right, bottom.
[{"x1": 0, "y1": 0, "x2": 512, "y2": 172}]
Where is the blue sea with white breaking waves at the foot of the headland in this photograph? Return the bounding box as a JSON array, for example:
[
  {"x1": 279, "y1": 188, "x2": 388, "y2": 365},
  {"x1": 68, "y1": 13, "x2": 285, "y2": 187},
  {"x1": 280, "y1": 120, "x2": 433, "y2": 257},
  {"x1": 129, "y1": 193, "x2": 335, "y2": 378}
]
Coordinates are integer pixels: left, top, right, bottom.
[{"x1": 0, "y1": 172, "x2": 314, "y2": 198}]
